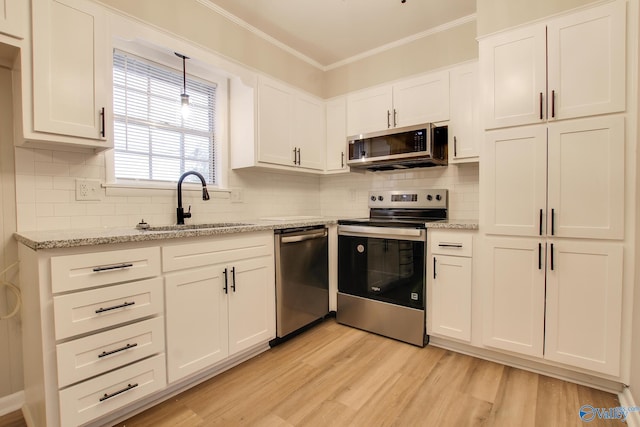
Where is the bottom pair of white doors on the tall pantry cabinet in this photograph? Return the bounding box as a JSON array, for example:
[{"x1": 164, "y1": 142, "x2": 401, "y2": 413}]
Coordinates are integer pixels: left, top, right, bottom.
[{"x1": 483, "y1": 237, "x2": 622, "y2": 376}]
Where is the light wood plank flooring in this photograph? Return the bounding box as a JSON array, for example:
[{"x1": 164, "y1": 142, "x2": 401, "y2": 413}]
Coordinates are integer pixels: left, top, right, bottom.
[{"x1": 0, "y1": 320, "x2": 623, "y2": 427}]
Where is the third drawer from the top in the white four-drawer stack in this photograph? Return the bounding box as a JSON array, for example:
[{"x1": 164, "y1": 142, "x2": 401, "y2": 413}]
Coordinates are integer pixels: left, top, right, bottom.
[{"x1": 56, "y1": 317, "x2": 164, "y2": 388}]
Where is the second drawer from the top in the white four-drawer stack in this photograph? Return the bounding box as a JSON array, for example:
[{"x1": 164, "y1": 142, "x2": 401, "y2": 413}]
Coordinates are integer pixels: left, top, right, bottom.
[{"x1": 53, "y1": 277, "x2": 164, "y2": 340}]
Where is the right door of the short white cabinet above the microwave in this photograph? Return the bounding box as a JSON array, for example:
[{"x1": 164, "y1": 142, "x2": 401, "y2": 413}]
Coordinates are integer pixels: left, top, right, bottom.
[{"x1": 391, "y1": 71, "x2": 449, "y2": 127}]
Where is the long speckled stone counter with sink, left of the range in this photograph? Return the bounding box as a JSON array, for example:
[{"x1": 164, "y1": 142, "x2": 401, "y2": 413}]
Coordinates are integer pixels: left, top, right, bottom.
[{"x1": 14, "y1": 216, "x2": 338, "y2": 250}]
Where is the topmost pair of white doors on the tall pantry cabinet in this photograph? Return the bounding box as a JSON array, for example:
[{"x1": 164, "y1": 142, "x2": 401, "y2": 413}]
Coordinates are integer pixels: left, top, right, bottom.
[{"x1": 480, "y1": 0, "x2": 626, "y2": 129}]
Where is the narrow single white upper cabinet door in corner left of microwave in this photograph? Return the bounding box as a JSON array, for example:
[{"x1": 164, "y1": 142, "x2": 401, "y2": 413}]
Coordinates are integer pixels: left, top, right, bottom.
[{"x1": 326, "y1": 97, "x2": 348, "y2": 172}]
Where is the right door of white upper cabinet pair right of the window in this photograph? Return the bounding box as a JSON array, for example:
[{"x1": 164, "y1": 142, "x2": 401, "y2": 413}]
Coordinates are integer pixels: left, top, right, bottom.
[{"x1": 292, "y1": 95, "x2": 326, "y2": 170}]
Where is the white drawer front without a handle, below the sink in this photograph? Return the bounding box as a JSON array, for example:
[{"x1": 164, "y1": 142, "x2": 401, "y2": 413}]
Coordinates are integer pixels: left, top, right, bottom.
[{"x1": 162, "y1": 232, "x2": 274, "y2": 271}]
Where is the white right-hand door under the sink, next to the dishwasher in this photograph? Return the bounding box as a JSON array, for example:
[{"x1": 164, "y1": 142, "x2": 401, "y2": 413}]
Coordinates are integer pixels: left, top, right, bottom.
[{"x1": 229, "y1": 257, "x2": 276, "y2": 355}]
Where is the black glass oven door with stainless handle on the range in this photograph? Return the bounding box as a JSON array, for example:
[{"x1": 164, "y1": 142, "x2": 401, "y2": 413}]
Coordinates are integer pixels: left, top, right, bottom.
[{"x1": 338, "y1": 225, "x2": 426, "y2": 310}]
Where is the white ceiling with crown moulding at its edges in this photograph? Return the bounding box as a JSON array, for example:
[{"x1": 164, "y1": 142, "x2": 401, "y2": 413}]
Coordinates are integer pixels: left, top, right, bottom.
[{"x1": 199, "y1": 0, "x2": 476, "y2": 68}]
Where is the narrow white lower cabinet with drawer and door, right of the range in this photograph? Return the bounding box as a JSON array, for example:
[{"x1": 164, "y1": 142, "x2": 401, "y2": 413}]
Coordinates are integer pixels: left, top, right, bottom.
[{"x1": 427, "y1": 231, "x2": 472, "y2": 342}]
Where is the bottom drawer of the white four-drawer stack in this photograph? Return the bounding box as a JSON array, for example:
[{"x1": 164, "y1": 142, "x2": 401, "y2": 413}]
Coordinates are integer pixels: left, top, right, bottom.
[{"x1": 60, "y1": 354, "x2": 167, "y2": 426}]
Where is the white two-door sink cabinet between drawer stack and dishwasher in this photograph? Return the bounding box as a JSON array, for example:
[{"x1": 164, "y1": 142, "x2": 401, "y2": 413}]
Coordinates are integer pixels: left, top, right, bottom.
[{"x1": 163, "y1": 233, "x2": 275, "y2": 382}]
